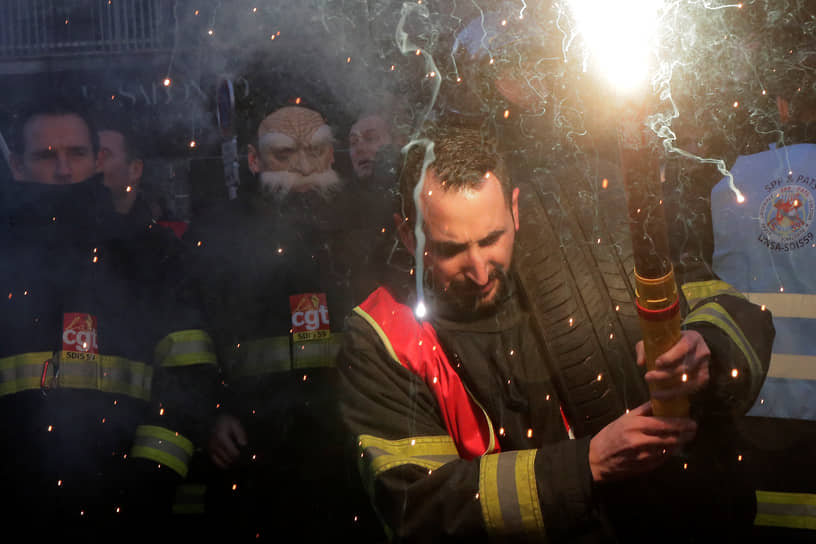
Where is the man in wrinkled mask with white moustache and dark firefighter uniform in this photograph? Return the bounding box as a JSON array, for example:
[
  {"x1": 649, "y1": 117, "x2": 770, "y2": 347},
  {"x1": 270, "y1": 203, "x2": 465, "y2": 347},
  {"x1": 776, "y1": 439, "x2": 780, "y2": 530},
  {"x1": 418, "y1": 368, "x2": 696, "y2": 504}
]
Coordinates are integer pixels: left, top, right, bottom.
[{"x1": 185, "y1": 102, "x2": 379, "y2": 541}]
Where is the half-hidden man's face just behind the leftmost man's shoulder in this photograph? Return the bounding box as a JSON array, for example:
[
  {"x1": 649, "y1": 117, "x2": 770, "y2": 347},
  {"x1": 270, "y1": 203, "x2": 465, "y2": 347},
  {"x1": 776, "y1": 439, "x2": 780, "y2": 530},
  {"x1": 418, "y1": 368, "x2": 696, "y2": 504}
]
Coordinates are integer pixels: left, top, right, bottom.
[{"x1": 99, "y1": 130, "x2": 144, "y2": 213}]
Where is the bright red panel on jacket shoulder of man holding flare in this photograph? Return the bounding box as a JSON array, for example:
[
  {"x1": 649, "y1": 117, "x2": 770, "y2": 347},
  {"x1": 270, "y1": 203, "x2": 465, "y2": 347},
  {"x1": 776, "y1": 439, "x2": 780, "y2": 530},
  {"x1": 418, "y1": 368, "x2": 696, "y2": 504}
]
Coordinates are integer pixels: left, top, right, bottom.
[{"x1": 360, "y1": 287, "x2": 499, "y2": 460}]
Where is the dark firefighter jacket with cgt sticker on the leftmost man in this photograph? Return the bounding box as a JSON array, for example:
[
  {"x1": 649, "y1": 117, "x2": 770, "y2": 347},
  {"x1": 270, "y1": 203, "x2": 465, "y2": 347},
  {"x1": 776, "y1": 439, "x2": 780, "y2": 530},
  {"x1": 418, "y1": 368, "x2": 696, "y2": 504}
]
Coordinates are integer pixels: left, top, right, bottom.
[{"x1": 0, "y1": 177, "x2": 216, "y2": 527}]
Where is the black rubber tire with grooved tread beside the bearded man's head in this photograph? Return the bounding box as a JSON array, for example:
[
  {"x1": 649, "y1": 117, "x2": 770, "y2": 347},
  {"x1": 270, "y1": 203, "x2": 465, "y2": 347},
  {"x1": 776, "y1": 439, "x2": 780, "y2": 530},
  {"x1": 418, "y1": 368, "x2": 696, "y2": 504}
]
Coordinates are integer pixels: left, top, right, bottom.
[{"x1": 516, "y1": 178, "x2": 648, "y2": 435}]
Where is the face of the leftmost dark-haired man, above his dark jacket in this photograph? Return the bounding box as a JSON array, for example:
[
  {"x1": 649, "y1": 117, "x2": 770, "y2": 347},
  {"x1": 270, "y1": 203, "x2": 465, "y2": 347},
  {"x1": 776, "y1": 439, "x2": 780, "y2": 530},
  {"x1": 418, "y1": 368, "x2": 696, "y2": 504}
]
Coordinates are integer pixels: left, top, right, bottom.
[{"x1": 11, "y1": 114, "x2": 97, "y2": 185}]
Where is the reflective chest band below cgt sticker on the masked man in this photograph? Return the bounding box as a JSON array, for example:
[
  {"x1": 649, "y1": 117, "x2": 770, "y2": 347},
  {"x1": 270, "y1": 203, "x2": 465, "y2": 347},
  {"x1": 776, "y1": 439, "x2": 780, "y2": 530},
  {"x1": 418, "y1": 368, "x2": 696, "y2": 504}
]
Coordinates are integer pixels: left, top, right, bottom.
[{"x1": 232, "y1": 332, "x2": 343, "y2": 377}]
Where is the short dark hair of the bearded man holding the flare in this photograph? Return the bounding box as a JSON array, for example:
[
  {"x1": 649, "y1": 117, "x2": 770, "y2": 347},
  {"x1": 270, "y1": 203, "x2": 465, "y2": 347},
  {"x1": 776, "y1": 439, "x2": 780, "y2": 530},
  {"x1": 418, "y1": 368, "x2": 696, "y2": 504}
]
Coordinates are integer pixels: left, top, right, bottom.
[{"x1": 399, "y1": 126, "x2": 513, "y2": 223}]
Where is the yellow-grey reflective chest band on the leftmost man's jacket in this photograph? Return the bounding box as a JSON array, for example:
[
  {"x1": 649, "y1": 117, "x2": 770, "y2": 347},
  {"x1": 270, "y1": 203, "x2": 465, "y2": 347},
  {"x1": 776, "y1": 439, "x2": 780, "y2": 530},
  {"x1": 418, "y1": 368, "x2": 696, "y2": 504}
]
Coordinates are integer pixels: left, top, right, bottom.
[{"x1": 0, "y1": 351, "x2": 153, "y2": 400}]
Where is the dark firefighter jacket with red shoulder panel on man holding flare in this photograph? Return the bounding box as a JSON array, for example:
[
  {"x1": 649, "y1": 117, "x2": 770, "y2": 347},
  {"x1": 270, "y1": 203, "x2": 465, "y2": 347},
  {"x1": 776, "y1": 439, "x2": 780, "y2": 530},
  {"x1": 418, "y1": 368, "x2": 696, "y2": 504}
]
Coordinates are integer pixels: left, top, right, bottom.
[{"x1": 338, "y1": 270, "x2": 770, "y2": 542}]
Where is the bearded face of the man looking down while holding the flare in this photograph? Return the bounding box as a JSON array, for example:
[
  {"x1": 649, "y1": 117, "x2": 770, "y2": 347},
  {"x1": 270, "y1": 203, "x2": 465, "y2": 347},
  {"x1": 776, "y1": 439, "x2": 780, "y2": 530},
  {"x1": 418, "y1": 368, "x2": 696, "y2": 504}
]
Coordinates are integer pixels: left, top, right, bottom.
[{"x1": 412, "y1": 168, "x2": 519, "y2": 314}]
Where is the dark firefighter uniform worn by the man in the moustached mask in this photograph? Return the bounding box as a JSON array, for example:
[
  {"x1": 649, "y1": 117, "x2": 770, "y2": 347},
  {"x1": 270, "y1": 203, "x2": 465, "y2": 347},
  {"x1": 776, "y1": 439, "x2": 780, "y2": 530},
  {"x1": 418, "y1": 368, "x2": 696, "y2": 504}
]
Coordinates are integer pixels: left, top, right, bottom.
[{"x1": 185, "y1": 193, "x2": 388, "y2": 540}]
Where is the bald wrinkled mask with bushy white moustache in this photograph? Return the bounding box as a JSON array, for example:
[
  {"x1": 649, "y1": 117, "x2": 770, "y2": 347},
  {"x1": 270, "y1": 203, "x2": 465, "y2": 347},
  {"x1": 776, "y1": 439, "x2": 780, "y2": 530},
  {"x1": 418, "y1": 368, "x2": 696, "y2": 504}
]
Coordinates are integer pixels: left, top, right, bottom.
[{"x1": 248, "y1": 106, "x2": 340, "y2": 196}]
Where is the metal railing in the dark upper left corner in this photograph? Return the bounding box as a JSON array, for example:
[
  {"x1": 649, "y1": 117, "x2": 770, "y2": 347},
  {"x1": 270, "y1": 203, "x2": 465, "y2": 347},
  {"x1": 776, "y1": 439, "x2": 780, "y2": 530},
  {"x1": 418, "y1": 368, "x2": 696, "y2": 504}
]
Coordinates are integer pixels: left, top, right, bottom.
[{"x1": 0, "y1": 0, "x2": 172, "y2": 58}]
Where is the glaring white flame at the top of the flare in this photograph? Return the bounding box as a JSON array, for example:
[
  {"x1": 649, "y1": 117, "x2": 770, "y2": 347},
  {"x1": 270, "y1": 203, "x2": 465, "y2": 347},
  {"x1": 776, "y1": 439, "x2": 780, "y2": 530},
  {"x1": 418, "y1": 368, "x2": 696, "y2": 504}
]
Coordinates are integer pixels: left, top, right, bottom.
[{"x1": 571, "y1": 0, "x2": 663, "y2": 92}]
